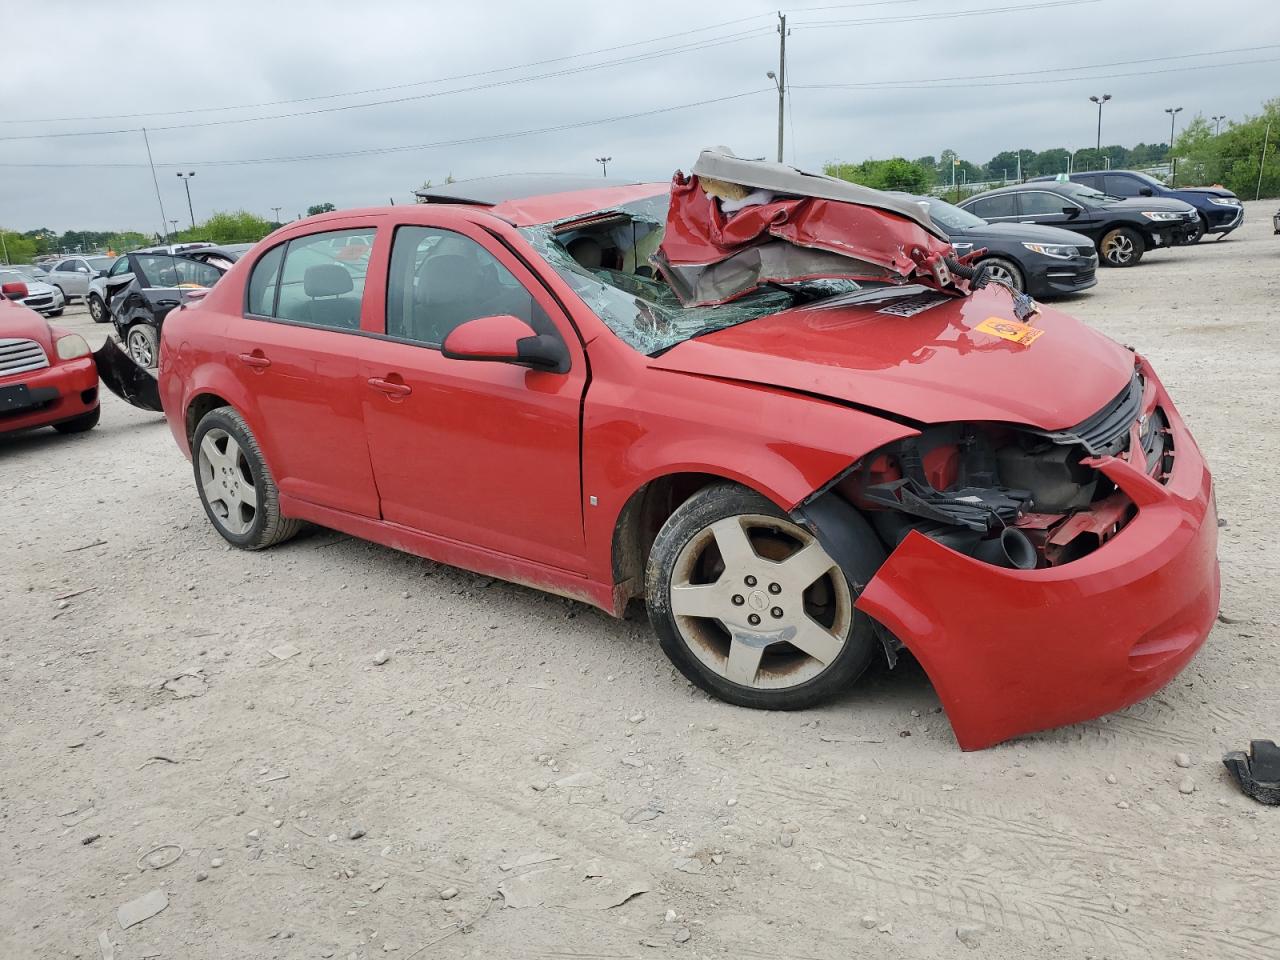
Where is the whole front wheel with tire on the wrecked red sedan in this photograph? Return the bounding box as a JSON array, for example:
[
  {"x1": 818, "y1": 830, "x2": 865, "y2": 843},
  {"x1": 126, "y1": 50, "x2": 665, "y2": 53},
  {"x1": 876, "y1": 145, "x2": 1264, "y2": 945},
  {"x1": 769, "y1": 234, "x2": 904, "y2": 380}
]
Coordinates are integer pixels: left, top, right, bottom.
[{"x1": 646, "y1": 484, "x2": 874, "y2": 710}]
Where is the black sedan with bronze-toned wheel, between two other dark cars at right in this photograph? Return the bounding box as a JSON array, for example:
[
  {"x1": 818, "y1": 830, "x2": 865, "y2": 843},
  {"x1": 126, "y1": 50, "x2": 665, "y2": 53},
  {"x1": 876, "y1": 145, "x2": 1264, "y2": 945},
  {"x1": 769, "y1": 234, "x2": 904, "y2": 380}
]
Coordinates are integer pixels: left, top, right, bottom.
[{"x1": 960, "y1": 180, "x2": 1199, "y2": 266}]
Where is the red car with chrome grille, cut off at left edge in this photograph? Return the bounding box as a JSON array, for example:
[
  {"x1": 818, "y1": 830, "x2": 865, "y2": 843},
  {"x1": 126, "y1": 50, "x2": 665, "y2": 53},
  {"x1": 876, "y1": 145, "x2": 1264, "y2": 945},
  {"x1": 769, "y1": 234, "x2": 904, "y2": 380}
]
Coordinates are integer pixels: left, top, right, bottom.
[{"x1": 0, "y1": 283, "x2": 99, "y2": 434}]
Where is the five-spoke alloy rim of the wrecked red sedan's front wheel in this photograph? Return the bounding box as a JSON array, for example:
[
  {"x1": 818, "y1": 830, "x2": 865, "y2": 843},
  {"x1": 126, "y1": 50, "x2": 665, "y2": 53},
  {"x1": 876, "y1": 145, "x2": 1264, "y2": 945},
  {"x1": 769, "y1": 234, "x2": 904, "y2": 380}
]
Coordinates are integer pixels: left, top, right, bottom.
[{"x1": 671, "y1": 515, "x2": 854, "y2": 690}]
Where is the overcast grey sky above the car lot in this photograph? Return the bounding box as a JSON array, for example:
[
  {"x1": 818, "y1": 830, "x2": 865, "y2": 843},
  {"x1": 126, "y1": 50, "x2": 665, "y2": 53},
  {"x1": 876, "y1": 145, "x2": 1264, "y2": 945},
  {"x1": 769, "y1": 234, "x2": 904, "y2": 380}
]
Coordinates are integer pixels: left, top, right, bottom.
[{"x1": 0, "y1": 0, "x2": 1280, "y2": 232}]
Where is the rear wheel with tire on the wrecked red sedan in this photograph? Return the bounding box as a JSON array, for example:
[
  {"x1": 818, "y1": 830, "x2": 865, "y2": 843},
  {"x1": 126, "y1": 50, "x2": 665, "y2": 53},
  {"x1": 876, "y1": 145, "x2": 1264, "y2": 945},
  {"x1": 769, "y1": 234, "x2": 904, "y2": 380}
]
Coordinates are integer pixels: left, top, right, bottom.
[{"x1": 191, "y1": 407, "x2": 302, "y2": 550}]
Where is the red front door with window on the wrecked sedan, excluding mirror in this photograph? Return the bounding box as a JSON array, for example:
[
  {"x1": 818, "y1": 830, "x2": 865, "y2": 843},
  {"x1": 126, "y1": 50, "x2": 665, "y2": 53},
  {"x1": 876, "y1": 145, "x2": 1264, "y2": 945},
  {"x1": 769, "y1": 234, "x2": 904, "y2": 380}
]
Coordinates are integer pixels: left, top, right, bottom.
[{"x1": 361, "y1": 221, "x2": 586, "y2": 573}]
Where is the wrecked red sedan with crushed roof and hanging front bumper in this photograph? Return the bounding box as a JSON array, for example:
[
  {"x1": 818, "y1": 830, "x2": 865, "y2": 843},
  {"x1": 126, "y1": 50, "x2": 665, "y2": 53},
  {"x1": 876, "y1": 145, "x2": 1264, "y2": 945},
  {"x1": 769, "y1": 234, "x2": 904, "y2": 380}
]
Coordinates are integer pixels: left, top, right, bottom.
[{"x1": 159, "y1": 151, "x2": 1219, "y2": 750}]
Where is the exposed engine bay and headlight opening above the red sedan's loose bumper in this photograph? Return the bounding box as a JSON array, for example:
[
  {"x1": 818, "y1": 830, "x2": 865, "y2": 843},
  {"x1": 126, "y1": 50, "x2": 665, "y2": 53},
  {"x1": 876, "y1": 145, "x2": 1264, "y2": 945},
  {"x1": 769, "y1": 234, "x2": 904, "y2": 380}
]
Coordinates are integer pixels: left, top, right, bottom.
[{"x1": 833, "y1": 372, "x2": 1174, "y2": 570}]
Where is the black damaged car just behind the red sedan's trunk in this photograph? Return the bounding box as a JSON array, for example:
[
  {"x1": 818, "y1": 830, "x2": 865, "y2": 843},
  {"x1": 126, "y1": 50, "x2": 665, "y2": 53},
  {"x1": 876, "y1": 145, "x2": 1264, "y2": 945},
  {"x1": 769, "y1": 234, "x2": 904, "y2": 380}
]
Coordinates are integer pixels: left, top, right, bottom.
[{"x1": 106, "y1": 243, "x2": 253, "y2": 369}]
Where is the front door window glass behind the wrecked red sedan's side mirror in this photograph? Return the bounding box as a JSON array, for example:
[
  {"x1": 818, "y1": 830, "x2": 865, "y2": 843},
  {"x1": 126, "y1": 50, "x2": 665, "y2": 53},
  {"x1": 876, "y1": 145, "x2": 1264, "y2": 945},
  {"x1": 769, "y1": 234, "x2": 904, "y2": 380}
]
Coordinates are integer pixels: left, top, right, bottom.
[{"x1": 386, "y1": 227, "x2": 554, "y2": 347}]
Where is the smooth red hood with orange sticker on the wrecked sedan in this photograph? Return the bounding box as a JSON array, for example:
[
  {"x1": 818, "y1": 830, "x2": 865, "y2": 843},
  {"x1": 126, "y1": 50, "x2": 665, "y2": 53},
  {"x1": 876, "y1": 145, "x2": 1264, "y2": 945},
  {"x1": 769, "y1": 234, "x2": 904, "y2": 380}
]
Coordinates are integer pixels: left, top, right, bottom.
[{"x1": 652, "y1": 287, "x2": 1134, "y2": 430}]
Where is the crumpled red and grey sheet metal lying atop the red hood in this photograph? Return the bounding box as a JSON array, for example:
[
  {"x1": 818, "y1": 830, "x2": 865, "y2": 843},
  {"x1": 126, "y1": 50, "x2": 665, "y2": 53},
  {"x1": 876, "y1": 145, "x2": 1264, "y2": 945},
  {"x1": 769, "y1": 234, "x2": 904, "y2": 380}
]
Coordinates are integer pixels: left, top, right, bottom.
[{"x1": 653, "y1": 148, "x2": 968, "y2": 307}]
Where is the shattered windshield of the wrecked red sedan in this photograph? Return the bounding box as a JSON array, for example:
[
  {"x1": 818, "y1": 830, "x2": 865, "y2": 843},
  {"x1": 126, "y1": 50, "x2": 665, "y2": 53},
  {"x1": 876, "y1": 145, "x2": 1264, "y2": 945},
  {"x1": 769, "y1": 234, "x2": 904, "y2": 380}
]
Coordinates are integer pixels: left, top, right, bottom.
[{"x1": 521, "y1": 193, "x2": 859, "y2": 356}]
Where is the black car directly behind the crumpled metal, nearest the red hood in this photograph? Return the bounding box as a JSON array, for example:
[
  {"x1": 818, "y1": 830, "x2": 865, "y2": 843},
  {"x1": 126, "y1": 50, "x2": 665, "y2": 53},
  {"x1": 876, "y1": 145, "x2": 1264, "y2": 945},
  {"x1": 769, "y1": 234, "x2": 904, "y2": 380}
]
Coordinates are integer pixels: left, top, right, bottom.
[{"x1": 893, "y1": 193, "x2": 1098, "y2": 298}]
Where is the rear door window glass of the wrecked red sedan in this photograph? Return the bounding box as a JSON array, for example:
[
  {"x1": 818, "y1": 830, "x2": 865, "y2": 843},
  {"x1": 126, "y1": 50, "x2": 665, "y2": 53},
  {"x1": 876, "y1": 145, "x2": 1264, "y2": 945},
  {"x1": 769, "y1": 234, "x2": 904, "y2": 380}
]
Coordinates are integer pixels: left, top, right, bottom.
[{"x1": 270, "y1": 227, "x2": 374, "y2": 330}]
